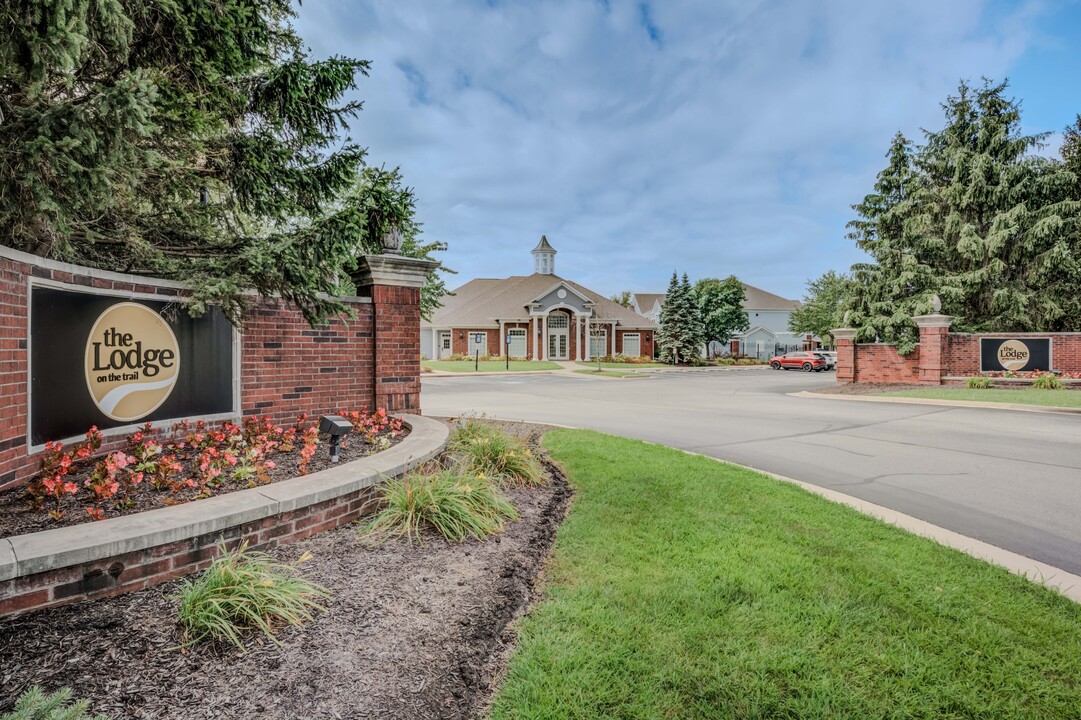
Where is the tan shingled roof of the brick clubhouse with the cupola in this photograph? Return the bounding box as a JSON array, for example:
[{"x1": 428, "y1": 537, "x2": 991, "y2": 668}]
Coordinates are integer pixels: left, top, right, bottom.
[{"x1": 421, "y1": 272, "x2": 656, "y2": 329}]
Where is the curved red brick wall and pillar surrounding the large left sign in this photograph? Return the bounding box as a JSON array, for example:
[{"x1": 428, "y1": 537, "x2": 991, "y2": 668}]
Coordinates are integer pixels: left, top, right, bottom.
[{"x1": 0, "y1": 248, "x2": 436, "y2": 490}]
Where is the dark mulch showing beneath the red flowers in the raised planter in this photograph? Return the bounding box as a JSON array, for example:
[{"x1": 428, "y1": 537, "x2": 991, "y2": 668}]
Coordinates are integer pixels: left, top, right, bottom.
[{"x1": 0, "y1": 429, "x2": 409, "y2": 537}]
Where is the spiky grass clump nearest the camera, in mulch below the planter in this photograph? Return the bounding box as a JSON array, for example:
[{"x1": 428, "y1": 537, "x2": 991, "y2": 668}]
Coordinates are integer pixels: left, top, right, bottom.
[{"x1": 179, "y1": 543, "x2": 330, "y2": 651}]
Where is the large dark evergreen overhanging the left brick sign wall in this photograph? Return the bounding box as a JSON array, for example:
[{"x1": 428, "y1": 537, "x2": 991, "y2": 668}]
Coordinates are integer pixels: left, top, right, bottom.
[{"x1": 0, "y1": 0, "x2": 443, "y2": 322}]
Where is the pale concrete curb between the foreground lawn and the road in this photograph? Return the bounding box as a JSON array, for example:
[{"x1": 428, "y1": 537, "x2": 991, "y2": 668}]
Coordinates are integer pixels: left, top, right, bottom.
[{"x1": 501, "y1": 417, "x2": 1081, "y2": 603}]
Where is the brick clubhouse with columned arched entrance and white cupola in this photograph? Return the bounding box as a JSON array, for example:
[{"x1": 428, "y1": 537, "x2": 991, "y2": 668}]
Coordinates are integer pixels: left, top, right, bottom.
[{"x1": 421, "y1": 236, "x2": 657, "y2": 360}]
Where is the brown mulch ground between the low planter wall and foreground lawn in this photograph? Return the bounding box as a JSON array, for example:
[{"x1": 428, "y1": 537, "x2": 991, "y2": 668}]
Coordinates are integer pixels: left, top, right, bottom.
[{"x1": 0, "y1": 417, "x2": 571, "y2": 720}]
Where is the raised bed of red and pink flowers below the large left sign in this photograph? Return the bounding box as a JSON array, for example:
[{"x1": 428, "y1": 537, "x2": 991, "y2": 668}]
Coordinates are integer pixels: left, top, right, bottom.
[{"x1": 0, "y1": 410, "x2": 405, "y2": 537}]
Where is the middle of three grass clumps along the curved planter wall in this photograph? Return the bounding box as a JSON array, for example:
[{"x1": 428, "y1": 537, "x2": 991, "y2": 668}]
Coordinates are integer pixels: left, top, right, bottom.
[{"x1": 360, "y1": 467, "x2": 518, "y2": 543}]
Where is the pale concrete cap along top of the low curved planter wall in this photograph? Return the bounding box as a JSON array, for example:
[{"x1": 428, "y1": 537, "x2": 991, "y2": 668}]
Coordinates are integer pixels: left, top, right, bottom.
[{"x1": 0, "y1": 415, "x2": 450, "y2": 581}]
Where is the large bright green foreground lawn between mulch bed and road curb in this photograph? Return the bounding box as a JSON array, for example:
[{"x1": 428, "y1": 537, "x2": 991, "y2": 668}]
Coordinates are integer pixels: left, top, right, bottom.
[{"x1": 492, "y1": 430, "x2": 1081, "y2": 720}]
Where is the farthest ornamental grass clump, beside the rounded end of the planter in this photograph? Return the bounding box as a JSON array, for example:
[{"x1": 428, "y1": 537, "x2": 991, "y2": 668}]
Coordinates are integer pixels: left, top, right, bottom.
[{"x1": 448, "y1": 419, "x2": 544, "y2": 488}]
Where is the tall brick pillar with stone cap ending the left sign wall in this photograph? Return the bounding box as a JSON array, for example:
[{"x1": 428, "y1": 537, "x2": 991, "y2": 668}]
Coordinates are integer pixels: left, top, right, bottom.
[{"x1": 353, "y1": 254, "x2": 439, "y2": 414}]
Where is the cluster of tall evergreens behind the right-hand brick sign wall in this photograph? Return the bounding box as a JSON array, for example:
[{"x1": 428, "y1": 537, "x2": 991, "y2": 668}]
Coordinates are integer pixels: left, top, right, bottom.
[{"x1": 846, "y1": 81, "x2": 1081, "y2": 351}]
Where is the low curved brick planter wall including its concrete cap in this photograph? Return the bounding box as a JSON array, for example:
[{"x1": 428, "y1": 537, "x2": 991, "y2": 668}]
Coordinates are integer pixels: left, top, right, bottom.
[{"x1": 0, "y1": 415, "x2": 448, "y2": 616}]
